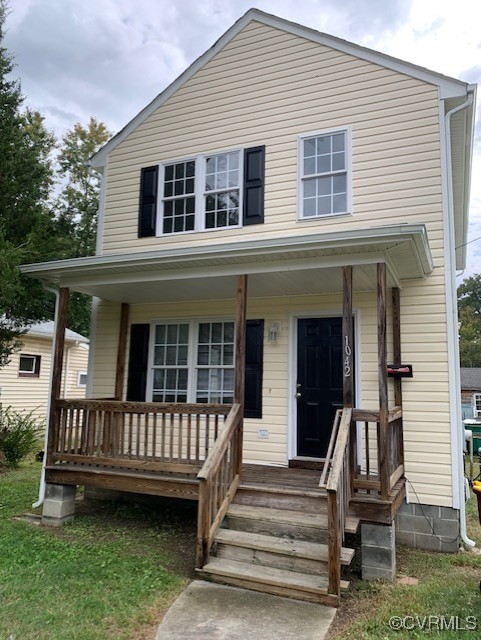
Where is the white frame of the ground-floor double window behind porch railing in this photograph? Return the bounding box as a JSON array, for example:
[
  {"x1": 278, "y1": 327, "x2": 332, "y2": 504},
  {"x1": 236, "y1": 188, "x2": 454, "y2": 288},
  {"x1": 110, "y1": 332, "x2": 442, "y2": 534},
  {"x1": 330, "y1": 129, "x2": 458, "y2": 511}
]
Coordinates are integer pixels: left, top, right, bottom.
[{"x1": 146, "y1": 316, "x2": 236, "y2": 404}]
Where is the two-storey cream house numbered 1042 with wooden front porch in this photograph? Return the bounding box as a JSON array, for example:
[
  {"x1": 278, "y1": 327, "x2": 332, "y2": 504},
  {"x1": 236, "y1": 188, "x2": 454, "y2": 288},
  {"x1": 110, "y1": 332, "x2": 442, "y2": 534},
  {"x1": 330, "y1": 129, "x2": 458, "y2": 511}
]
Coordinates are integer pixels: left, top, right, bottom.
[{"x1": 23, "y1": 10, "x2": 475, "y2": 603}]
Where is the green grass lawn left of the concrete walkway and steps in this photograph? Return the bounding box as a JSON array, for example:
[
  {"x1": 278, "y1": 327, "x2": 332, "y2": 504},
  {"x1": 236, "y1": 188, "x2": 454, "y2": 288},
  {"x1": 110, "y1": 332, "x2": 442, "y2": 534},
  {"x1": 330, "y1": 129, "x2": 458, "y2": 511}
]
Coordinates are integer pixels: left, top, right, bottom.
[{"x1": 0, "y1": 463, "x2": 196, "y2": 640}]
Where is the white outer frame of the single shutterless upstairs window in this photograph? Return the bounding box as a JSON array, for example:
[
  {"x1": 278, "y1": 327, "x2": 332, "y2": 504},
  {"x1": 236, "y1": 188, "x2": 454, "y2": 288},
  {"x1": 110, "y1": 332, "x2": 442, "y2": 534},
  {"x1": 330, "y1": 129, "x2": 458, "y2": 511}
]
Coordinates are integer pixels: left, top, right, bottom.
[{"x1": 297, "y1": 125, "x2": 352, "y2": 222}]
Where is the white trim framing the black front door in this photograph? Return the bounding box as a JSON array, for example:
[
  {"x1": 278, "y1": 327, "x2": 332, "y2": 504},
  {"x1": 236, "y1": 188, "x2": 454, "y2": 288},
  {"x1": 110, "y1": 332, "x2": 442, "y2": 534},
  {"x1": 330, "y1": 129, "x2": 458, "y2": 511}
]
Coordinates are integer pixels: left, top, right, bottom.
[{"x1": 287, "y1": 308, "x2": 362, "y2": 462}]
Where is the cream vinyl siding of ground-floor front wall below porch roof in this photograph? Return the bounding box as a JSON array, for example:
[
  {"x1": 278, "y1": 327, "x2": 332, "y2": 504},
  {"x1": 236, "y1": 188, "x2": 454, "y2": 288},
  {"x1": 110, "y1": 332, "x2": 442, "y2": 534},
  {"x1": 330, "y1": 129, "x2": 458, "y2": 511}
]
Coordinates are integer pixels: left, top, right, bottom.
[{"x1": 94, "y1": 270, "x2": 452, "y2": 506}]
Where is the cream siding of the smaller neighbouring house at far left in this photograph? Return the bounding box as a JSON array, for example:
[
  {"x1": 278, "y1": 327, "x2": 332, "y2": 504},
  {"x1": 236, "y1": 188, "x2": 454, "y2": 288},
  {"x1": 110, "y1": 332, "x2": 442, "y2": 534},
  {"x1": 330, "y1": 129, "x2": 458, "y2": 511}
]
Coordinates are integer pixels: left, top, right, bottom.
[{"x1": 0, "y1": 335, "x2": 89, "y2": 428}]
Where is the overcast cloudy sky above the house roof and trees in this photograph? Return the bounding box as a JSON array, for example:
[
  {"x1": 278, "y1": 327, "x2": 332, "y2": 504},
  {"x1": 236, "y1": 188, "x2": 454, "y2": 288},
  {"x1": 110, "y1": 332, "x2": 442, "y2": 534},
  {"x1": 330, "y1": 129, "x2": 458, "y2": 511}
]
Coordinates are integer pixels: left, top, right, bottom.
[{"x1": 5, "y1": 0, "x2": 481, "y2": 275}]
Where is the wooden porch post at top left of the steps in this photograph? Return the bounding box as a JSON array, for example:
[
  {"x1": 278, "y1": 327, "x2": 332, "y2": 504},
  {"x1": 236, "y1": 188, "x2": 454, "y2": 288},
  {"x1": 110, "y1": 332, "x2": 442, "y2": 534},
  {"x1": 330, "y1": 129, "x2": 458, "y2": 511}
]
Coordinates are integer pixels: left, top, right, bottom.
[{"x1": 234, "y1": 275, "x2": 247, "y2": 476}]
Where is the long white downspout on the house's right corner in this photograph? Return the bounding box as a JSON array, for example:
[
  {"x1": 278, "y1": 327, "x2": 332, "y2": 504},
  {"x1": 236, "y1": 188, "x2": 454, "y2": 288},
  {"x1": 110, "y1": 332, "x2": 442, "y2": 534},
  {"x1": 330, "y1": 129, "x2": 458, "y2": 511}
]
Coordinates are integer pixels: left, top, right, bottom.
[{"x1": 445, "y1": 90, "x2": 476, "y2": 547}]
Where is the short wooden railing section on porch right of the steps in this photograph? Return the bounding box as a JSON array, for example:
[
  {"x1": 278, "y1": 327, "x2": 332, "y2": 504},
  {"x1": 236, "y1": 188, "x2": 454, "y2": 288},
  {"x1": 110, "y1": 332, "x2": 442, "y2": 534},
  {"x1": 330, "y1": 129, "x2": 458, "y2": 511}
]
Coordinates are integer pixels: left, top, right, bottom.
[{"x1": 352, "y1": 407, "x2": 404, "y2": 496}]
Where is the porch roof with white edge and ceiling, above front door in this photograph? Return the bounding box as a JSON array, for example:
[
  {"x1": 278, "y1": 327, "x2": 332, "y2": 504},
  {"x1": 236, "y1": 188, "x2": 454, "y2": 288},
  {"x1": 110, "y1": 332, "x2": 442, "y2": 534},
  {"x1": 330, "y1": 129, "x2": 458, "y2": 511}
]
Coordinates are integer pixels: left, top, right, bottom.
[{"x1": 20, "y1": 224, "x2": 433, "y2": 304}]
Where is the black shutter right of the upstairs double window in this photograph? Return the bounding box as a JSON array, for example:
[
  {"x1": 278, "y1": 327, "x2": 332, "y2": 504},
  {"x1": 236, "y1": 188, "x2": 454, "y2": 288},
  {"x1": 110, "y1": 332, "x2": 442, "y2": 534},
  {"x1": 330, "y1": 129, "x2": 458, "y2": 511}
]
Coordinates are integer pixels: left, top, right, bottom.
[{"x1": 243, "y1": 146, "x2": 266, "y2": 225}]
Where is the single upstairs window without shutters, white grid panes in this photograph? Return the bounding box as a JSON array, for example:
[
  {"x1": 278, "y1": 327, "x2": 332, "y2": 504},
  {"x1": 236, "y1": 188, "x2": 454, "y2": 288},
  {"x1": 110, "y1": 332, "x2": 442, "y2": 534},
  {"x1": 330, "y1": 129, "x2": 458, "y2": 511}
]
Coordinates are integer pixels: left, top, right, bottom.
[{"x1": 299, "y1": 130, "x2": 350, "y2": 219}]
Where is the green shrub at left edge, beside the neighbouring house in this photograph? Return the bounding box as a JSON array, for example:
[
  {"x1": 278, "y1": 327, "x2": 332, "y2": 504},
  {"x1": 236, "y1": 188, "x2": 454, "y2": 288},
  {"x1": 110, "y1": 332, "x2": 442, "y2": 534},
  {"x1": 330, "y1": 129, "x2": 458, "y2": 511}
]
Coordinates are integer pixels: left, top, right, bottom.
[{"x1": 0, "y1": 404, "x2": 40, "y2": 467}]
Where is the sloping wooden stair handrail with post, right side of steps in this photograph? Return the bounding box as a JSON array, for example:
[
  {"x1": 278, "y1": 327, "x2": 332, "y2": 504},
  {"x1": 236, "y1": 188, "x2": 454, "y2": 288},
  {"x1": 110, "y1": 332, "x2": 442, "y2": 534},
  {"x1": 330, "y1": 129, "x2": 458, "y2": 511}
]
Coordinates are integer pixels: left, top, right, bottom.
[{"x1": 319, "y1": 408, "x2": 352, "y2": 598}]
